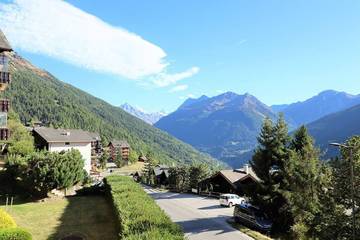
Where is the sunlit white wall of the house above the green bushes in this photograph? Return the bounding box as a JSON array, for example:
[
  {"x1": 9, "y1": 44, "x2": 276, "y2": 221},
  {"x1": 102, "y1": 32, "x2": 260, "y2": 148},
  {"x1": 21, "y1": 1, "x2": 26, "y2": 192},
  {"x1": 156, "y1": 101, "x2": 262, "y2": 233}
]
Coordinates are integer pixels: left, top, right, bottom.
[{"x1": 49, "y1": 142, "x2": 91, "y2": 174}]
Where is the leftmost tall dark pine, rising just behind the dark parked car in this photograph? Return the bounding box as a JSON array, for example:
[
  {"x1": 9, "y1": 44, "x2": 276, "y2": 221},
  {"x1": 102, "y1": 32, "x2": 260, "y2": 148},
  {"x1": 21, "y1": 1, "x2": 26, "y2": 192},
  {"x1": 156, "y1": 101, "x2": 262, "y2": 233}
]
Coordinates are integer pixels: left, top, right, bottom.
[{"x1": 248, "y1": 115, "x2": 292, "y2": 231}]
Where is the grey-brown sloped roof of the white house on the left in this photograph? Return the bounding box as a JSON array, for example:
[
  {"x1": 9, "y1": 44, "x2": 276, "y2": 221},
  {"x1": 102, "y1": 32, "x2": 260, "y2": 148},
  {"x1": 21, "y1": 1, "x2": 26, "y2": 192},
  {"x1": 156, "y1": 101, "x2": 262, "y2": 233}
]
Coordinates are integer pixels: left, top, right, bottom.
[{"x1": 33, "y1": 127, "x2": 93, "y2": 143}]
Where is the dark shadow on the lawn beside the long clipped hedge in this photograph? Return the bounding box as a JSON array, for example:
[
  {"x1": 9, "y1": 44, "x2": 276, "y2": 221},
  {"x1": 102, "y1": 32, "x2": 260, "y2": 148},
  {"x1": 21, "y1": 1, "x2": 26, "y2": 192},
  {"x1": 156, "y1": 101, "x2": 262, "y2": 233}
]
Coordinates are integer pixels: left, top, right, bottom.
[{"x1": 48, "y1": 195, "x2": 119, "y2": 240}]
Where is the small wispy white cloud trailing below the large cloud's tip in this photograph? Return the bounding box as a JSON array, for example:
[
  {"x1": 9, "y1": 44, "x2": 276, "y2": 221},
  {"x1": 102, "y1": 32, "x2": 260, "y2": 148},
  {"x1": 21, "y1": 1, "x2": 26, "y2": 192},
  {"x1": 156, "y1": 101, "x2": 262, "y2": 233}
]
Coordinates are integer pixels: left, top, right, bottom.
[{"x1": 152, "y1": 67, "x2": 200, "y2": 87}]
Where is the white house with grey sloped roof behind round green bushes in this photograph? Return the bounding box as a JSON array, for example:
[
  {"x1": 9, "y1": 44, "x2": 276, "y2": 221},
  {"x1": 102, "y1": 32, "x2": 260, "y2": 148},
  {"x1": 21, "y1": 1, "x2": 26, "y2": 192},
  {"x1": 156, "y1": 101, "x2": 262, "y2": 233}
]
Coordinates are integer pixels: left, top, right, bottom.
[{"x1": 33, "y1": 127, "x2": 93, "y2": 173}]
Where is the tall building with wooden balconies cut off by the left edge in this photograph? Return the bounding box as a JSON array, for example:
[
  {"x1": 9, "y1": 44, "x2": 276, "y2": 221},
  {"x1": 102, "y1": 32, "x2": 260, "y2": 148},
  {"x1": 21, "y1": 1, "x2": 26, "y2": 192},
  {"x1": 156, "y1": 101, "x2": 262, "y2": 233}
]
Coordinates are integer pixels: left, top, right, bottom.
[{"x1": 0, "y1": 30, "x2": 12, "y2": 140}]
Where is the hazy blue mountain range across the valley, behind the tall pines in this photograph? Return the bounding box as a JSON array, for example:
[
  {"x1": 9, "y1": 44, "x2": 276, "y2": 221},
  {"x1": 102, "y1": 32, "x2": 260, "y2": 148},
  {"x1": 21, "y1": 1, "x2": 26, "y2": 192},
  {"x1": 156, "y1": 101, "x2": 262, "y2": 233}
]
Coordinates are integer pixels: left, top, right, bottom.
[{"x1": 155, "y1": 90, "x2": 360, "y2": 167}]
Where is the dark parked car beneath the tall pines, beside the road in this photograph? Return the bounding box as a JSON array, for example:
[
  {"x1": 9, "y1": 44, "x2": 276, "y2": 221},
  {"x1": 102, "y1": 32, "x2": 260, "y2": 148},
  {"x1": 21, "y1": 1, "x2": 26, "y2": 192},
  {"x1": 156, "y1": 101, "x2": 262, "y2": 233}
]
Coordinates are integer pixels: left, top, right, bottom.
[{"x1": 234, "y1": 203, "x2": 272, "y2": 232}]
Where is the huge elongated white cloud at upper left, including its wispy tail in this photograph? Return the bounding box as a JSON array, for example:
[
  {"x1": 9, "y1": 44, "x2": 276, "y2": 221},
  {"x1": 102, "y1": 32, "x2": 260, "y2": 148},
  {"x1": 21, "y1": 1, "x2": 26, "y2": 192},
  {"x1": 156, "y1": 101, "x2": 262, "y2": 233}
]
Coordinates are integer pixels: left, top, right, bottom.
[{"x1": 0, "y1": 0, "x2": 198, "y2": 86}]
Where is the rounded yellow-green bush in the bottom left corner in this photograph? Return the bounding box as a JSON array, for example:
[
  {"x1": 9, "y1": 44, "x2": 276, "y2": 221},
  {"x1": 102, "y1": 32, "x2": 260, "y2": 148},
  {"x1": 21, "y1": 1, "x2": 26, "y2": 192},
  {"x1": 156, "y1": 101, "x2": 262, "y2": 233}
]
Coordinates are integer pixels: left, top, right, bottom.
[{"x1": 0, "y1": 209, "x2": 32, "y2": 240}]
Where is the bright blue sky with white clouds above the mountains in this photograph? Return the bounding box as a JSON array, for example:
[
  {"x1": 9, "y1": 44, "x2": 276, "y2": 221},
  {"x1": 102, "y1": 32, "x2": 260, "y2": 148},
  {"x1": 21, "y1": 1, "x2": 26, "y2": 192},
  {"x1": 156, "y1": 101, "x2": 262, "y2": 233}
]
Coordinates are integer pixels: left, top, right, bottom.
[{"x1": 0, "y1": 0, "x2": 360, "y2": 112}]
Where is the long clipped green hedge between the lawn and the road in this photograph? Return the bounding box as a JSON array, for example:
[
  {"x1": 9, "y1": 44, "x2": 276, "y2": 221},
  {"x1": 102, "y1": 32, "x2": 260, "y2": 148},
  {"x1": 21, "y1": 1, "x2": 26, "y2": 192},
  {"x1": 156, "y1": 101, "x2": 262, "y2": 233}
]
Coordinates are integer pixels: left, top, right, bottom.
[{"x1": 105, "y1": 176, "x2": 184, "y2": 240}]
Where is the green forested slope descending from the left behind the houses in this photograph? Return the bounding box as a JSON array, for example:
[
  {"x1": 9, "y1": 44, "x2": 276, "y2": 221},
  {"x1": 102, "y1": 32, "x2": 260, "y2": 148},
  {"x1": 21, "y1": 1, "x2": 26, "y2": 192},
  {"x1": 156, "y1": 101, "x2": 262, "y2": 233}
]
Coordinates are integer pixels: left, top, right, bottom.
[{"x1": 5, "y1": 54, "x2": 219, "y2": 166}]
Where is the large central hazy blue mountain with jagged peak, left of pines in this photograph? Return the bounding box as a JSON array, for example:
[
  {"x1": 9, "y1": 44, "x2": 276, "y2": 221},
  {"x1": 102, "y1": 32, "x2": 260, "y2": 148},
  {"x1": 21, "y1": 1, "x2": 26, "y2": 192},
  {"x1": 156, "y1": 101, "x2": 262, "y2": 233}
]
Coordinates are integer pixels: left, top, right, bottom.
[{"x1": 155, "y1": 92, "x2": 276, "y2": 165}]
